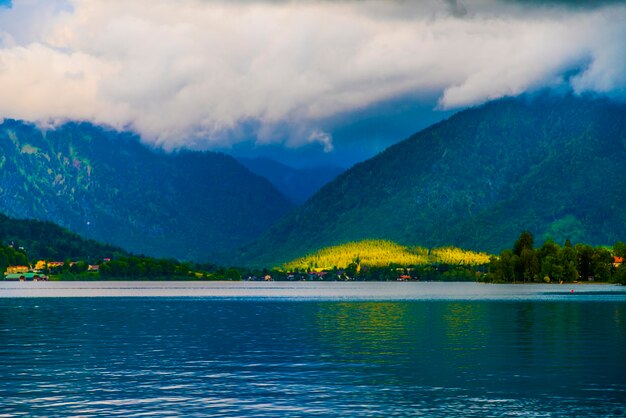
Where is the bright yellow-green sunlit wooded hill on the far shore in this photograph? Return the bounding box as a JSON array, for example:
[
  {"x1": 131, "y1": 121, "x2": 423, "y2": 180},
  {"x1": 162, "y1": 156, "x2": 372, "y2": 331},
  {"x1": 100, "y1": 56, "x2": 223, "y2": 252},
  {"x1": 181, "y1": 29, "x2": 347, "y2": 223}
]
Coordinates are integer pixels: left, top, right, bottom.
[{"x1": 282, "y1": 240, "x2": 489, "y2": 271}]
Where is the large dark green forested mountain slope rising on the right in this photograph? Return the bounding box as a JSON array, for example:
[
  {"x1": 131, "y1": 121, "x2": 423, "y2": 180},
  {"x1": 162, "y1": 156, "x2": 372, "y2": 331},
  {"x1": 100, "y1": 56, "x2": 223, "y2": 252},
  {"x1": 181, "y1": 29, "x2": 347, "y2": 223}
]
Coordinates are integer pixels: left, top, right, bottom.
[{"x1": 241, "y1": 94, "x2": 626, "y2": 264}]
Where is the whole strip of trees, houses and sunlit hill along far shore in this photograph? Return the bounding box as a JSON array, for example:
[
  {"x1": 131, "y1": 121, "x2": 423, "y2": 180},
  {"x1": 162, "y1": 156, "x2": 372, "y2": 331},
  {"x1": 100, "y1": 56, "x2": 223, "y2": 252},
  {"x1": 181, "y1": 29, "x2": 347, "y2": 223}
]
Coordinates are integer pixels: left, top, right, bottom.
[{"x1": 0, "y1": 231, "x2": 626, "y2": 284}]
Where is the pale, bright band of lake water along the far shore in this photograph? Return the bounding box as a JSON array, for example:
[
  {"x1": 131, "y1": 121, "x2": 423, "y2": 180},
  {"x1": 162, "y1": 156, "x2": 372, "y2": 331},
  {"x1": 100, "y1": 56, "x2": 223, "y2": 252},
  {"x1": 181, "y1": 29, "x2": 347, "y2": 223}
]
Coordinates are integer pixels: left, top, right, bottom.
[{"x1": 0, "y1": 281, "x2": 626, "y2": 302}]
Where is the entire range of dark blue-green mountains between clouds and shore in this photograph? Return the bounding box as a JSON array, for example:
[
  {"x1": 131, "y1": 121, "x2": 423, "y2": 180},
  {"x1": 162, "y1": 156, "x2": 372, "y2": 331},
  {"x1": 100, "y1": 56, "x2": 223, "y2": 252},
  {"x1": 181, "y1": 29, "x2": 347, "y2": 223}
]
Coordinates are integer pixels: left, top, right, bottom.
[{"x1": 0, "y1": 93, "x2": 626, "y2": 266}]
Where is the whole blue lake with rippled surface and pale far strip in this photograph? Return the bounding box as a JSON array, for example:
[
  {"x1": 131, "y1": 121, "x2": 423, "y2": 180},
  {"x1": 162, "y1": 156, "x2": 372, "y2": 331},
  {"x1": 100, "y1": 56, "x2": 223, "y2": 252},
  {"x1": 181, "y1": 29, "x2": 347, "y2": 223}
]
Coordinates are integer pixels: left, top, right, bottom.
[{"x1": 0, "y1": 282, "x2": 626, "y2": 417}]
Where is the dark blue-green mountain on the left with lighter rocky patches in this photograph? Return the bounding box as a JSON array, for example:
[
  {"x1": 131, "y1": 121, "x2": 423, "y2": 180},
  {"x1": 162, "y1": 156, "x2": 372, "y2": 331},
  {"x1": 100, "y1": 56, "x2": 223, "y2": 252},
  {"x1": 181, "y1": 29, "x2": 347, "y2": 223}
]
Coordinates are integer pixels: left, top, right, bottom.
[{"x1": 0, "y1": 120, "x2": 292, "y2": 260}]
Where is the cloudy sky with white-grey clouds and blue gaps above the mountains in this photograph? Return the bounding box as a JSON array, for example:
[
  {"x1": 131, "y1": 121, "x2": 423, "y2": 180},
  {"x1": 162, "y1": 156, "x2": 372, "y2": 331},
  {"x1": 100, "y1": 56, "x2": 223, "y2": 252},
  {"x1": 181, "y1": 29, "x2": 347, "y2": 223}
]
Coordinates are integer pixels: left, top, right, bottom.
[{"x1": 0, "y1": 0, "x2": 626, "y2": 164}]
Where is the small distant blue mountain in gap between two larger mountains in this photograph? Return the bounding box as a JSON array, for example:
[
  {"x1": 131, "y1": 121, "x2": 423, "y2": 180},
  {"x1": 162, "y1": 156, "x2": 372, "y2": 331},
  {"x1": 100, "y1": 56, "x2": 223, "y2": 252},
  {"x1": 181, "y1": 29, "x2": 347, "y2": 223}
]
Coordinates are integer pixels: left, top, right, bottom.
[{"x1": 237, "y1": 158, "x2": 345, "y2": 205}]
